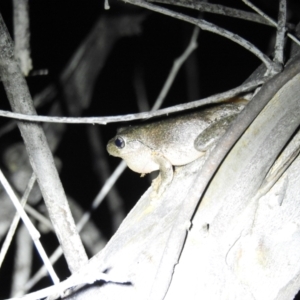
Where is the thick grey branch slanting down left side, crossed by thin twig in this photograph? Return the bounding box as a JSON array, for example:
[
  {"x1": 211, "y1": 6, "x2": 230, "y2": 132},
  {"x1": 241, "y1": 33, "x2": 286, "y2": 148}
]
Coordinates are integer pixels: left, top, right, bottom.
[{"x1": 0, "y1": 15, "x2": 87, "y2": 272}]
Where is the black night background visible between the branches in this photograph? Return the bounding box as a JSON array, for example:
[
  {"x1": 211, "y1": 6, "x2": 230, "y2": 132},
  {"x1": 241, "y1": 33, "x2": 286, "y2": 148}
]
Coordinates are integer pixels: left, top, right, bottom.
[{"x1": 0, "y1": 0, "x2": 300, "y2": 298}]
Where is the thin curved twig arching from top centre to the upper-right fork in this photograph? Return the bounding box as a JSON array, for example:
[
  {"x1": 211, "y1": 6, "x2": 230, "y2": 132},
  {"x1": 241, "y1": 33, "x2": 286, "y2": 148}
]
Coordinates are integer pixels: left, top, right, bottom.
[{"x1": 126, "y1": 0, "x2": 274, "y2": 74}]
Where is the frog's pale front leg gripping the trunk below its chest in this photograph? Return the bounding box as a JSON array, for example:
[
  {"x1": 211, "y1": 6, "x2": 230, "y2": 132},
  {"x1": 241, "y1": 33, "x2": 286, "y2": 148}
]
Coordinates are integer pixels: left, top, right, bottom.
[{"x1": 151, "y1": 151, "x2": 173, "y2": 198}]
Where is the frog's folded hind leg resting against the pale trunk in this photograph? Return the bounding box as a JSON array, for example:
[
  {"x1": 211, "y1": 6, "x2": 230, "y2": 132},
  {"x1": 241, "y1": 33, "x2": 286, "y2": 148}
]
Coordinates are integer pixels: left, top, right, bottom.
[{"x1": 194, "y1": 114, "x2": 237, "y2": 152}]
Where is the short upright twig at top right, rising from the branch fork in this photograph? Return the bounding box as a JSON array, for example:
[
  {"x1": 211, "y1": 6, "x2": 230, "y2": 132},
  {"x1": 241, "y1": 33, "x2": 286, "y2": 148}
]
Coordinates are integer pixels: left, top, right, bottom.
[{"x1": 274, "y1": 0, "x2": 286, "y2": 66}]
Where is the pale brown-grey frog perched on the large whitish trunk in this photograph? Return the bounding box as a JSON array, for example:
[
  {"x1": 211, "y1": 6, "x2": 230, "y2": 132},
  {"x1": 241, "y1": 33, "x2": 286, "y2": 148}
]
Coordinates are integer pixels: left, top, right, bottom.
[{"x1": 107, "y1": 103, "x2": 245, "y2": 198}]
